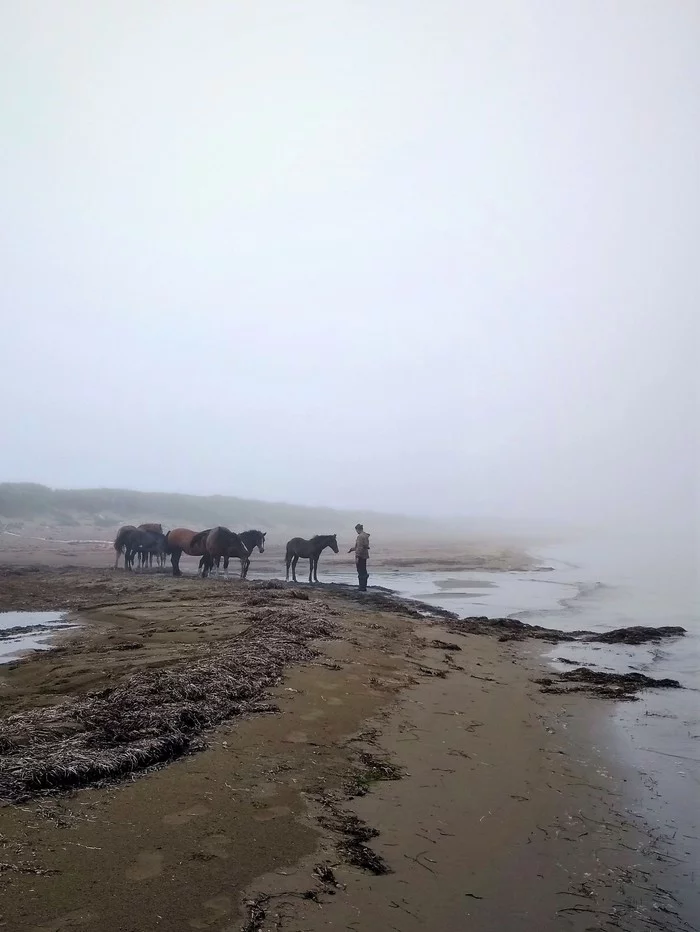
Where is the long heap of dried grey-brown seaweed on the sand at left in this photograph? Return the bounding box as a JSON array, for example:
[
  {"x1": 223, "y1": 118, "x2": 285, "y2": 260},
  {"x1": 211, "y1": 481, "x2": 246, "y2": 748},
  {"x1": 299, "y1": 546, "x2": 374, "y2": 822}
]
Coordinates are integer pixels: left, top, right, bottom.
[{"x1": 0, "y1": 610, "x2": 333, "y2": 801}]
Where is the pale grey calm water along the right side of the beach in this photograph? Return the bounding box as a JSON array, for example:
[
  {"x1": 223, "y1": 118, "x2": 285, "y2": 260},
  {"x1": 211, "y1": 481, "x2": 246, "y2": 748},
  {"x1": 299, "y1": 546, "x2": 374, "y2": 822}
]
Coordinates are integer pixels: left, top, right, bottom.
[{"x1": 326, "y1": 534, "x2": 700, "y2": 928}]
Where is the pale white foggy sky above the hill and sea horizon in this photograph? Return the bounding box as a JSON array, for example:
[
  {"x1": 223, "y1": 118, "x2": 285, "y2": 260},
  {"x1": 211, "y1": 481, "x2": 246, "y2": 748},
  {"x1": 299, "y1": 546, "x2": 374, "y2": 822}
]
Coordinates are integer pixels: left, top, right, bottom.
[{"x1": 0, "y1": 0, "x2": 700, "y2": 522}]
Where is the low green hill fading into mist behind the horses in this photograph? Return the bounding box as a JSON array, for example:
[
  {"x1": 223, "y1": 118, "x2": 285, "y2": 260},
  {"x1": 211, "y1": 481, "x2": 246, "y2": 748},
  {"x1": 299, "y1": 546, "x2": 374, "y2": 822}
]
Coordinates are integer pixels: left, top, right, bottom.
[{"x1": 0, "y1": 482, "x2": 456, "y2": 537}]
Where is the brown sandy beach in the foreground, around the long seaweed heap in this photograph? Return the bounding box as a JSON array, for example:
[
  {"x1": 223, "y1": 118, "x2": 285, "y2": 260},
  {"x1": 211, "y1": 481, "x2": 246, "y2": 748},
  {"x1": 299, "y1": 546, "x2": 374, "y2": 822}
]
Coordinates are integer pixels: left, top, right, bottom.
[{"x1": 0, "y1": 567, "x2": 684, "y2": 932}]
